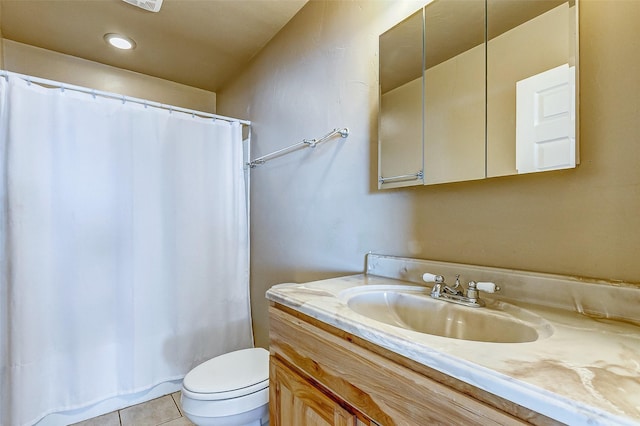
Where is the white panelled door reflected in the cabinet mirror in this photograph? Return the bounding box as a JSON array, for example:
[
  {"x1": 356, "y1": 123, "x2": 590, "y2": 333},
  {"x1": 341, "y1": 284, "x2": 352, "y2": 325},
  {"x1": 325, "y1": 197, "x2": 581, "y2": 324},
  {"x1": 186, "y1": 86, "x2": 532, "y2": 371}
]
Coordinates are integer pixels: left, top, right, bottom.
[{"x1": 516, "y1": 64, "x2": 576, "y2": 174}]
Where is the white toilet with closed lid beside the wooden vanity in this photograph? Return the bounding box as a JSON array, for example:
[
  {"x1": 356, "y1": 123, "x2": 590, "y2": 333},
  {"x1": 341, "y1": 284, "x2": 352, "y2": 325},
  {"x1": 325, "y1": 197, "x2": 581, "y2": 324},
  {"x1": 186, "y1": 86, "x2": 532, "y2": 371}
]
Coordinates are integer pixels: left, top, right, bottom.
[{"x1": 181, "y1": 348, "x2": 269, "y2": 426}]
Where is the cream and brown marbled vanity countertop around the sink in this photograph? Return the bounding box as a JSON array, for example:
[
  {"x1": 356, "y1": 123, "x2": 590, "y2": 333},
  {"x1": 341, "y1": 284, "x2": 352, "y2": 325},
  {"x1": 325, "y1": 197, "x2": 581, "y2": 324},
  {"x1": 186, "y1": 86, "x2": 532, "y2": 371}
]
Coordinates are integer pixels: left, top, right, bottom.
[{"x1": 267, "y1": 274, "x2": 640, "y2": 425}]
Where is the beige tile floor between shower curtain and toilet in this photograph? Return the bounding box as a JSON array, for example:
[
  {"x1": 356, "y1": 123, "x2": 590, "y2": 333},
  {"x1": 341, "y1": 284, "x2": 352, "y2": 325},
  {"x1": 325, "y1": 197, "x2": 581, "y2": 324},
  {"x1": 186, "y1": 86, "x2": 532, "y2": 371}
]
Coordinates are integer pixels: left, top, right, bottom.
[{"x1": 74, "y1": 392, "x2": 193, "y2": 426}]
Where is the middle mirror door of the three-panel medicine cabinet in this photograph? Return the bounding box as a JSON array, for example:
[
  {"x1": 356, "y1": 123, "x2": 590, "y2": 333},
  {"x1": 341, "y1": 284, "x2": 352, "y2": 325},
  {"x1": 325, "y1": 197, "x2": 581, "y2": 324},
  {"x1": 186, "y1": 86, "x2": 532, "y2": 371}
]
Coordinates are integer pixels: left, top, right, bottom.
[{"x1": 424, "y1": 0, "x2": 486, "y2": 185}]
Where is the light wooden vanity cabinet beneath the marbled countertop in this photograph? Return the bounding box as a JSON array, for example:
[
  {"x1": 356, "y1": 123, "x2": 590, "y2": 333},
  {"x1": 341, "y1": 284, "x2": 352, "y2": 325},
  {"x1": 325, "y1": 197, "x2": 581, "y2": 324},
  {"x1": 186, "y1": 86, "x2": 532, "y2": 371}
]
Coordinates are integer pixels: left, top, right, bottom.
[{"x1": 269, "y1": 303, "x2": 557, "y2": 426}]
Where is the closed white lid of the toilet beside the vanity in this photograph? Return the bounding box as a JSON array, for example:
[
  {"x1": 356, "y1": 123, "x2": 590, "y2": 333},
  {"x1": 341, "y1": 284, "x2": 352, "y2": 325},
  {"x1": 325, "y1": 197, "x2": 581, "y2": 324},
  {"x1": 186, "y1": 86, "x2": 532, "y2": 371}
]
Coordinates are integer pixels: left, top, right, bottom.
[{"x1": 182, "y1": 348, "x2": 269, "y2": 399}]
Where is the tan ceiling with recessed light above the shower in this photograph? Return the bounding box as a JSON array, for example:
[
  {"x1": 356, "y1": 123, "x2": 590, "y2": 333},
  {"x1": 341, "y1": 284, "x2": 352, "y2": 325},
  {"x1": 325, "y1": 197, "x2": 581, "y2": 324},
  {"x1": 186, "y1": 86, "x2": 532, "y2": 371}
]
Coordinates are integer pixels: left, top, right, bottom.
[{"x1": 0, "y1": 0, "x2": 307, "y2": 92}]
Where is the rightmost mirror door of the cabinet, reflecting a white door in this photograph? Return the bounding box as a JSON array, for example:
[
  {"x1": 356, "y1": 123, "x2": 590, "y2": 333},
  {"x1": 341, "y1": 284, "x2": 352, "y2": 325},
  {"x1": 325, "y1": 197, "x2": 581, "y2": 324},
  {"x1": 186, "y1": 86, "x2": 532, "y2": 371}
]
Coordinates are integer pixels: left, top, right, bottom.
[{"x1": 487, "y1": 0, "x2": 578, "y2": 177}]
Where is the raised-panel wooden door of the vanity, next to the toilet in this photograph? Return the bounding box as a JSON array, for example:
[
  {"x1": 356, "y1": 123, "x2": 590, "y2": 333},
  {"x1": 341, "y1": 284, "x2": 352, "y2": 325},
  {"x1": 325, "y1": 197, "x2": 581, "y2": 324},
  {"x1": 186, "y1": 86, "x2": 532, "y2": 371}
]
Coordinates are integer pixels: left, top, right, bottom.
[{"x1": 269, "y1": 356, "x2": 356, "y2": 426}]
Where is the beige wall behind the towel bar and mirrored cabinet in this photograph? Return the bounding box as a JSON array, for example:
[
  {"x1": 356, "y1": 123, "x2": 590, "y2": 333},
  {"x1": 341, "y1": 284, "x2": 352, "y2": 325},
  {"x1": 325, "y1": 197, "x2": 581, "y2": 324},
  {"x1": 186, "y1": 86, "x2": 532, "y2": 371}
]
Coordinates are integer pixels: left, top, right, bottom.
[{"x1": 218, "y1": 0, "x2": 640, "y2": 346}]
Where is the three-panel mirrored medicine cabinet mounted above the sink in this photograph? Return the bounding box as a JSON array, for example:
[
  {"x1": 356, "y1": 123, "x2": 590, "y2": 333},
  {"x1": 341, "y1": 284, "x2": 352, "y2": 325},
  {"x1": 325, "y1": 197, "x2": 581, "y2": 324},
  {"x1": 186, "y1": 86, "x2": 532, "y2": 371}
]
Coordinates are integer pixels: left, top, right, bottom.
[{"x1": 378, "y1": 0, "x2": 578, "y2": 189}]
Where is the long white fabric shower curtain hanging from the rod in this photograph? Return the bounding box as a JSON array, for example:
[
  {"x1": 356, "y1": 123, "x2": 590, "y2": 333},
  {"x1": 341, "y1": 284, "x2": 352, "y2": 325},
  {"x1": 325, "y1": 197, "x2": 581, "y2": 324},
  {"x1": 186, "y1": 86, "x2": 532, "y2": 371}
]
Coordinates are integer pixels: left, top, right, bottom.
[{"x1": 0, "y1": 75, "x2": 253, "y2": 426}]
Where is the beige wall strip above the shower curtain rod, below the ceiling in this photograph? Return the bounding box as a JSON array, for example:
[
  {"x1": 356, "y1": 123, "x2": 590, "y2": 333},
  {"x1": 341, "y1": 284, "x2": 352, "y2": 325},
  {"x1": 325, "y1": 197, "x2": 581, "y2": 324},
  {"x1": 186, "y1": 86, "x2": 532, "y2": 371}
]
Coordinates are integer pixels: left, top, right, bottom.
[{"x1": 0, "y1": 40, "x2": 216, "y2": 113}]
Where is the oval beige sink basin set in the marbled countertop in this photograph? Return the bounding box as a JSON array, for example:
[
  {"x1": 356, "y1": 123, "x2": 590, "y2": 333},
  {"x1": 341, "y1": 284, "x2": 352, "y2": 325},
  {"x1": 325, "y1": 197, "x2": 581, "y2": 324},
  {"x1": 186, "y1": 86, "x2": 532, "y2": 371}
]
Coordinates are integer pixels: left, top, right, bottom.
[{"x1": 339, "y1": 285, "x2": 553, "y2": 343}]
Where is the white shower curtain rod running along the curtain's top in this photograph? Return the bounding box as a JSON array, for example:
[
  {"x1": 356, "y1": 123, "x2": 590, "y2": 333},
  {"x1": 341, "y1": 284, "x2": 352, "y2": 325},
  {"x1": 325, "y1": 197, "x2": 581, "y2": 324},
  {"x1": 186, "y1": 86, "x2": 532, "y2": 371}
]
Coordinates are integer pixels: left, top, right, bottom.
[{"x1": 0, "y1": 70, "x2": 251, "y2": 126}]
